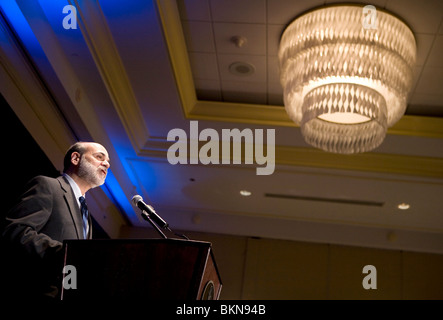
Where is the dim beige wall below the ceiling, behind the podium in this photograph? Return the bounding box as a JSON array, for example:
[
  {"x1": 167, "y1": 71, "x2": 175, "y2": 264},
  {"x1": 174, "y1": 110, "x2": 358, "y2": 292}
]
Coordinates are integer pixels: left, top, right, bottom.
[{"x1": 120, "y1": 227, "x2": 443, "y2": 300}]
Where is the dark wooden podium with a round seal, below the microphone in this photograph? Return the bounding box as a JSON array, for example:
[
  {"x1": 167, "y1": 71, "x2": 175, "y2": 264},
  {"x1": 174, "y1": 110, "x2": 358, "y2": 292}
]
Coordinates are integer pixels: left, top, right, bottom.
[{"x1": 61, "y1": 239, "x2": 222, "y2": 300}]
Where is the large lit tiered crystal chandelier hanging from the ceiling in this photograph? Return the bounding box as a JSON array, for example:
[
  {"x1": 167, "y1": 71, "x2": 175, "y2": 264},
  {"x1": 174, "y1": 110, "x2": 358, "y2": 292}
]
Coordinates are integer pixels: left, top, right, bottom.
[{"x1": 278, "y1": 5, "x2": 416, "y2": 154}]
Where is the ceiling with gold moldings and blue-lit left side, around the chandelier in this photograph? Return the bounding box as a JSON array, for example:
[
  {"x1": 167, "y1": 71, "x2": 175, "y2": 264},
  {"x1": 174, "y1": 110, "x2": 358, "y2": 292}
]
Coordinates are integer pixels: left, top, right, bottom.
[{"x1": 0, "y1": 0, "x2": 443, "y2": 253}]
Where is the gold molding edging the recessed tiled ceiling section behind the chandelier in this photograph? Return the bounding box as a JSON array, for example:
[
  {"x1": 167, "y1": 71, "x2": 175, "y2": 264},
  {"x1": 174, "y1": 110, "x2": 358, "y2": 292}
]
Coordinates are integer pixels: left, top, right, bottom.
[{"x1": 157, "y1": 0, "x2": 443, "y2": 139}]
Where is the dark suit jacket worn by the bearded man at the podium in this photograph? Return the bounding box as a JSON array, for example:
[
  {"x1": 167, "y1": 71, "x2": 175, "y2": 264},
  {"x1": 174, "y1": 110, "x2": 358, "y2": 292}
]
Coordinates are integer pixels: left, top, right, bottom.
[{"x1": 2, "y1": 176, "x2": 92, "y2": 296}]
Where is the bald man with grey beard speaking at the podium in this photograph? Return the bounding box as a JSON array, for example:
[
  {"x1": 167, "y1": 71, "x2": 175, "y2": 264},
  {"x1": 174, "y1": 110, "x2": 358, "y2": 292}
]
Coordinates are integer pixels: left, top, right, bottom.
[{"x1": 2, "y1": 142, "x2": 110, "y2": 298}]
